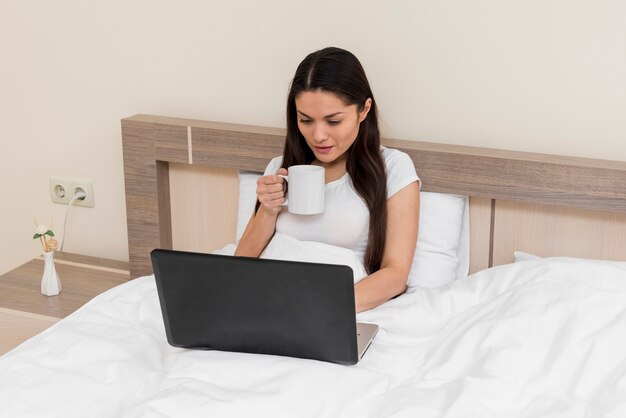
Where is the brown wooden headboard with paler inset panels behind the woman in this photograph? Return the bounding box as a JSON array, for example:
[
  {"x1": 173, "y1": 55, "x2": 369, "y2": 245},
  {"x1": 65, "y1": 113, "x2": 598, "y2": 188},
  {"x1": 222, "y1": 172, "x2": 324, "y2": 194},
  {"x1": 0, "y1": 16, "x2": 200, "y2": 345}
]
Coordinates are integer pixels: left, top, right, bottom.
[{"x1": 122, "y1": 115, "x2": 626, "y2": 277}]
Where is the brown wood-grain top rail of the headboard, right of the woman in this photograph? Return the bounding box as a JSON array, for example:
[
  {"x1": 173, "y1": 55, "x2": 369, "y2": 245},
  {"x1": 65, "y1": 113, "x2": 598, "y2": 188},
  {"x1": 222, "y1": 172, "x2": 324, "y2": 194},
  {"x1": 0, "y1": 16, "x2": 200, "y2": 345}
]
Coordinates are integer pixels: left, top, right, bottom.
[{"x1": 384, "y1": 139, "x2": 626, "y2": 212}]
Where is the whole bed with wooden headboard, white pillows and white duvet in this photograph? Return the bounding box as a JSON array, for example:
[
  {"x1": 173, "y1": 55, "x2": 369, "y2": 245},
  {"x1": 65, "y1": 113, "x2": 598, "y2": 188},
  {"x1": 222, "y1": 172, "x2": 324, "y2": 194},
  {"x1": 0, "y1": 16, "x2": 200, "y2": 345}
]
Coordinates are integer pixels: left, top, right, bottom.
[{"x1": 0, "y1": 115, "x2": 626, "y2": 418}]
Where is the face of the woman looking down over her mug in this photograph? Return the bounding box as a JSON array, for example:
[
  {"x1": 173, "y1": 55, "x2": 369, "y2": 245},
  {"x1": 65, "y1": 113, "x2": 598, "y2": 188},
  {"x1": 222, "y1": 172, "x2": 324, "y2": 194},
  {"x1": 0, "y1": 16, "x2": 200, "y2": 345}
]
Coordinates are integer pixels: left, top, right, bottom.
[{"x1": 295, "y1": 90, "x2": 372, "y2": 164}]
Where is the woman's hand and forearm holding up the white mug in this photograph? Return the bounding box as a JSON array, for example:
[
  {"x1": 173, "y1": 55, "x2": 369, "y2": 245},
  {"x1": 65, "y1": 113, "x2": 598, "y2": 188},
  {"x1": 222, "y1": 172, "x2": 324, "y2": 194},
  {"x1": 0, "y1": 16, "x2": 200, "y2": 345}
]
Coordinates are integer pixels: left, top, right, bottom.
[{"x1": 235, "y1": 168, "x2": 287, "y2": 257}]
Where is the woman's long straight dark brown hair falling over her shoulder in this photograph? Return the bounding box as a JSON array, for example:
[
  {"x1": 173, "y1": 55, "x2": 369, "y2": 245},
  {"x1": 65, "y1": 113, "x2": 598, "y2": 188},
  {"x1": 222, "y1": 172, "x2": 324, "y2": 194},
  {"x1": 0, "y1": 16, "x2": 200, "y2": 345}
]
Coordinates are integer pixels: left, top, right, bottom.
[{"x1": 282, "y1": 47, "x2": 387, "y2": 274}]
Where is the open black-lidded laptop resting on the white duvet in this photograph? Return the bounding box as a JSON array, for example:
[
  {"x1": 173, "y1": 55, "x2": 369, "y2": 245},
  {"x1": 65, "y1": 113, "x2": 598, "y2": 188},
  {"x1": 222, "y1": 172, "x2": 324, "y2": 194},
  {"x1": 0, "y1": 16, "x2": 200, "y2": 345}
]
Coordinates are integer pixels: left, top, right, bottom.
[{"x1": 151, "y1": 249, "x2": 378, "y2": 364}]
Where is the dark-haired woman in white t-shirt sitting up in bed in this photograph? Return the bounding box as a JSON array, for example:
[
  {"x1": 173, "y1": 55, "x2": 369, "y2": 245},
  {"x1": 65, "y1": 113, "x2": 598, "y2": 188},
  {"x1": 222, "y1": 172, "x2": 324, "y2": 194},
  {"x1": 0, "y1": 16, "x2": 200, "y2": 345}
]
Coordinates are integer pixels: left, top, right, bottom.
[{"x1": 235, "y1": 48, "x2": 419, "y2": 312}]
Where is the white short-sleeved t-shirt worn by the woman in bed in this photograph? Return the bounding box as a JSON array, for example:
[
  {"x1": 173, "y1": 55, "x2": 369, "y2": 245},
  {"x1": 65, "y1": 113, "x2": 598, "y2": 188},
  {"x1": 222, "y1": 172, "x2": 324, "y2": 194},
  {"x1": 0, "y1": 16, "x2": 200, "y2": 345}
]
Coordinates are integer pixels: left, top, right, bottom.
[{"x1": 265, "y1": 147, "x2": 420, "y2": 262}]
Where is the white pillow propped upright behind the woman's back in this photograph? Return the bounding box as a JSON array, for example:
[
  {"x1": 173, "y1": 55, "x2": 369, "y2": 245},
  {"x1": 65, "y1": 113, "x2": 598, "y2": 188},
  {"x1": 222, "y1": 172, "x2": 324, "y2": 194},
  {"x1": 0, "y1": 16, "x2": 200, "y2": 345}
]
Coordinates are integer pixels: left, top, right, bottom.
[{"x1": 236, "y1": 171, "x2": 469, "y2": 288}]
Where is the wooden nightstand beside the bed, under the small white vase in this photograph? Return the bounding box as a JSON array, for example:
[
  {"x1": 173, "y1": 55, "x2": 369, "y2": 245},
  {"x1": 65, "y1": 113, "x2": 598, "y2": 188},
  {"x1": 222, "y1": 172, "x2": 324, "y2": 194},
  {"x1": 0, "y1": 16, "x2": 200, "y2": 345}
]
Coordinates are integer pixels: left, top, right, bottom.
[{"x1": 0, "y1": 253, "x2": 130, "y2": 355}]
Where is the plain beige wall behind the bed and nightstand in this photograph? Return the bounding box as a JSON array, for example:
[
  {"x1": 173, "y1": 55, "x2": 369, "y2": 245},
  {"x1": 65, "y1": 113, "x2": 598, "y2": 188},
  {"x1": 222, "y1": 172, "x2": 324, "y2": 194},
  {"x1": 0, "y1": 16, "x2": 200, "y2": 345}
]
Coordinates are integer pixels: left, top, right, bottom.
[{"x1": 0, "y1": 0, "x2": 626, "y2": 272}]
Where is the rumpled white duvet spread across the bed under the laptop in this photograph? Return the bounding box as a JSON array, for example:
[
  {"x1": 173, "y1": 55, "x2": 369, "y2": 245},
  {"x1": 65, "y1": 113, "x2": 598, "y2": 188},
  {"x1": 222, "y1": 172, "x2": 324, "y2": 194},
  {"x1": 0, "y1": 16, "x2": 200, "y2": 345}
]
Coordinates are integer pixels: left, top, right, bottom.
[{"x1": 0, "y1": 240, "x2": 626, "y2": 418}]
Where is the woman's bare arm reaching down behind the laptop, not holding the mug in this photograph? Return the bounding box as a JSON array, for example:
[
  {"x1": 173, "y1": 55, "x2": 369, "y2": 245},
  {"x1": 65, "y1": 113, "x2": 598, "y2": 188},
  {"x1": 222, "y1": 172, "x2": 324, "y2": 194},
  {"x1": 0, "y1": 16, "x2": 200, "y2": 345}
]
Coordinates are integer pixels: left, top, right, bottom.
[{"x1": 354, "y1": 182, "x2": 420, "y2": 312}]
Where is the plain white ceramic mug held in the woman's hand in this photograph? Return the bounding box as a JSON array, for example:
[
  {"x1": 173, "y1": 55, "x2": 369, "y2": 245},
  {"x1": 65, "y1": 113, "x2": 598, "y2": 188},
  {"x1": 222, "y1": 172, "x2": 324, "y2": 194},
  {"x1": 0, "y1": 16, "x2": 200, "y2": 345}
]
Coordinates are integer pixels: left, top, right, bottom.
[{"x1": 281, "y1": 165, "x2": 326, "y2": 215}]
